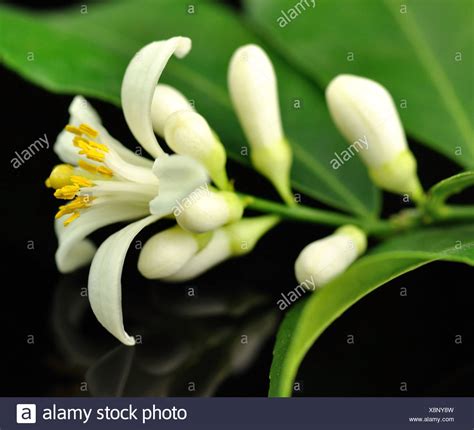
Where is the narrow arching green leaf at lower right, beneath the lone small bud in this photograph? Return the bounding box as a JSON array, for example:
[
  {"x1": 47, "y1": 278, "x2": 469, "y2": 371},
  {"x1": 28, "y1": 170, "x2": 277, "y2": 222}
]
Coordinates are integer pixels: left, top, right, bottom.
[{"x1": 269, "y1": 224, "x2": 474, "y2": 397}]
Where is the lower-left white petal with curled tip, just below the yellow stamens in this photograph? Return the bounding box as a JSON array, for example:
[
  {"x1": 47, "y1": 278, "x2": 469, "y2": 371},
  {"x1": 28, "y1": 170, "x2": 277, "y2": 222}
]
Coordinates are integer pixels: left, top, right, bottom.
[{"x1": 55, "y1": 202, "x2": 149, "y2": 273}]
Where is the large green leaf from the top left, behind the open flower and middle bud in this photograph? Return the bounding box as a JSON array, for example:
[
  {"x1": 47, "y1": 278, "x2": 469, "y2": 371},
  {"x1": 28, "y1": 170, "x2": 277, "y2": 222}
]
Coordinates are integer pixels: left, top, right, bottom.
[{"x1": 0, "y1": 0, "x2": 379, "y2": 216}]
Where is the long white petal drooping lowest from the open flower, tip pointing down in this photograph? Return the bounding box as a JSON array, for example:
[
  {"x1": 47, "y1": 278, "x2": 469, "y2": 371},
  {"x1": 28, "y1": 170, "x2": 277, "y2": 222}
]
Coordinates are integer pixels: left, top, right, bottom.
[{"x1": 89, "y1": 216, "x2": 159, "y2": 345}]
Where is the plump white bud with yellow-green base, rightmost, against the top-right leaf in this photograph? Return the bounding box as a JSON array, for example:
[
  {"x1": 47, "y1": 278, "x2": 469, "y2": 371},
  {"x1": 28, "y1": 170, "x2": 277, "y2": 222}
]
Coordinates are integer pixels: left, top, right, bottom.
[{"x1": 326, "y1": 75, "x2": 423, "y2": 201}]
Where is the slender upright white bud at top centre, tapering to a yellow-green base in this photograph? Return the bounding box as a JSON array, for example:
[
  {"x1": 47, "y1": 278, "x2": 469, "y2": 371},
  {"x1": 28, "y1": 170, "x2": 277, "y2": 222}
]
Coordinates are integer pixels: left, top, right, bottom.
[{"x1": 228, "y1": 45, "x2": 294, "y2": 204}]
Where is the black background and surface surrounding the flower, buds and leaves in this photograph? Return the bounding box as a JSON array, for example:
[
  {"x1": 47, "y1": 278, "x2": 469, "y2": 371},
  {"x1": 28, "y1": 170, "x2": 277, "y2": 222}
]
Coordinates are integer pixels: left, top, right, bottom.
[{"x1": 0, "y1": 1, "x2": 474, "y2": 396}]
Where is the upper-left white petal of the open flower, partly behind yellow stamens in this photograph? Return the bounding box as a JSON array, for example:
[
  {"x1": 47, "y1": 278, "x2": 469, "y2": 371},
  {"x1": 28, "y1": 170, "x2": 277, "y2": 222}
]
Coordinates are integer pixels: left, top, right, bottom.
[{"x1": 54, "y1": 96, "x2": 153, "y2": 168}]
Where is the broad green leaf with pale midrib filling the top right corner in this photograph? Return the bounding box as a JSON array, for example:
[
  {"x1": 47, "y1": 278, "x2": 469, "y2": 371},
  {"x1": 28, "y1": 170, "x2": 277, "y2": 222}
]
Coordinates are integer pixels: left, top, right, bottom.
[{"x1": 245, "y1": 0, "x2": 474, "y2": 168}]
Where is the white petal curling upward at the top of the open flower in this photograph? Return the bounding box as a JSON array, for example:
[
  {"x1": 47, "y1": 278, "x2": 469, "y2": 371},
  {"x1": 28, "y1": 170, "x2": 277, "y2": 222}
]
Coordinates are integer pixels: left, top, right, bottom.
[{"x1": 121, "y1": 37, "x2": 191, "y2": 158}]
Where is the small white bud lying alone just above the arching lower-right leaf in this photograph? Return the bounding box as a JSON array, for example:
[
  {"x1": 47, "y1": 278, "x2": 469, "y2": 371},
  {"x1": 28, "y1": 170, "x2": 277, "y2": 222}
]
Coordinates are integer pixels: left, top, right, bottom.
[{"x1": 295, "y1": 225, "x2": 367, "y2": 287}]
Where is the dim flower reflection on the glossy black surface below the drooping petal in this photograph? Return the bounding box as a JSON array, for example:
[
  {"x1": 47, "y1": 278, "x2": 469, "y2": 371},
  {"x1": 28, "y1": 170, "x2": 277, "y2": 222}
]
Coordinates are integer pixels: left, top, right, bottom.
[{"x1": 52, "y1": 271, "x2": 278, "y2": 396}]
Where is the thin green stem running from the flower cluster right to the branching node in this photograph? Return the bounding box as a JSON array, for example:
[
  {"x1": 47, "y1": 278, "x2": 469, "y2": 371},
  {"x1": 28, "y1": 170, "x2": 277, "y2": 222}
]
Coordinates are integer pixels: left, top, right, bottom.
[{"x1": 239, "y1": 194, "x2": 397, "y2": 235}]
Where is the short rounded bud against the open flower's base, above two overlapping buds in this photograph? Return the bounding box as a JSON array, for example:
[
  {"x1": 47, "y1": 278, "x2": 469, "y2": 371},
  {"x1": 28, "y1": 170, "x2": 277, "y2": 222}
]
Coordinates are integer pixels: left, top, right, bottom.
[{"x1": 174, "y1": 189, "x2": 244, "y2": 233}]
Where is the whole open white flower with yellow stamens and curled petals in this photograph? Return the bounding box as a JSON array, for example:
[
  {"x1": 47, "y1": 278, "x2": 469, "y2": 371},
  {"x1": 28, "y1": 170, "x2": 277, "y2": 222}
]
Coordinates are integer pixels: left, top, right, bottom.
[{"x1": 46, "y1": 37, "x2": 215, "y2": 345}]
